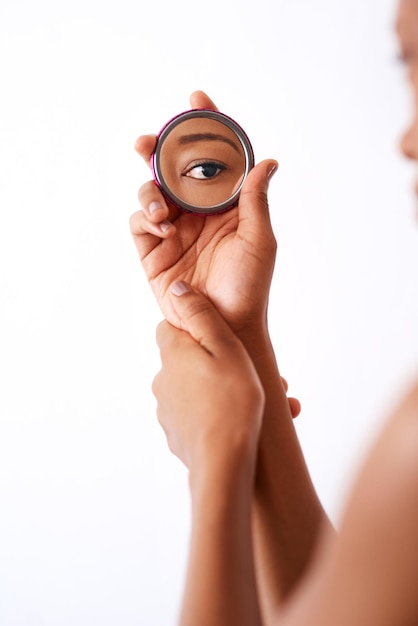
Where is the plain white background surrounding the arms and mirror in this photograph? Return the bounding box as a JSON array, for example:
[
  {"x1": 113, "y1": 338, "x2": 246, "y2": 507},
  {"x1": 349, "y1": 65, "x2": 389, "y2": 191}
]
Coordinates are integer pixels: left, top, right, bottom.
[{"x1": 0, "y1": 0, "x2": 418, "y2": 626}]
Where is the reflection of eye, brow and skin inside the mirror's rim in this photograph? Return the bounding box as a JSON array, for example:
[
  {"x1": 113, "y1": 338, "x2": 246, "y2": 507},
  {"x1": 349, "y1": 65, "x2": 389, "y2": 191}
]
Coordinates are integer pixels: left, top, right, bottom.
[{"x1": 161, "y1": 118, "x2": 245, "y2": 207}]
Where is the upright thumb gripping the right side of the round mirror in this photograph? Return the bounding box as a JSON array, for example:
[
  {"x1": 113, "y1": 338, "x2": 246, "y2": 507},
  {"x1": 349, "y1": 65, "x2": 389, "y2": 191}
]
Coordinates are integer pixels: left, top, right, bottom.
[{"x1": 238, "y1": 159, "x2": 279, "y2": 239}]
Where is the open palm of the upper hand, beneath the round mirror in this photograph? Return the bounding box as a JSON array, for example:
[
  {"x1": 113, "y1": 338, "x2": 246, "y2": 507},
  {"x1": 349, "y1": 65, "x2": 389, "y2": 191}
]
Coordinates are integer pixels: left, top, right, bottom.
[{"x1": 138, "y1": 208, "x2": 273, "y2": 329}]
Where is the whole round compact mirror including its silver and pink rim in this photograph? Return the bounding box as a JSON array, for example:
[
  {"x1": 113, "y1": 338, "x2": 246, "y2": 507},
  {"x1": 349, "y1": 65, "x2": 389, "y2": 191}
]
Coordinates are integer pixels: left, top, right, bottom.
[{"x1": 152, "y1": 109, "x2": 254, "y2": 215}]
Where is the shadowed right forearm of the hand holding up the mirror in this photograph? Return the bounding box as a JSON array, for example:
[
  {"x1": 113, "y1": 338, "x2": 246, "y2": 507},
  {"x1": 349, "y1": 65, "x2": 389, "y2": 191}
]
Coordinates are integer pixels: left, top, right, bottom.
[{"x1": 240, "y1": 328, "x2": 330, "y2": 623}]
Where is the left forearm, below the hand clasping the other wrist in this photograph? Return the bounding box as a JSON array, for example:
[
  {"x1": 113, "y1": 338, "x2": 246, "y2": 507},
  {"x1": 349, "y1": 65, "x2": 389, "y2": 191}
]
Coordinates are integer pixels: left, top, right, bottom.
[{"x1": 180, "y1": 444, "x2": 261, "y2": 626}]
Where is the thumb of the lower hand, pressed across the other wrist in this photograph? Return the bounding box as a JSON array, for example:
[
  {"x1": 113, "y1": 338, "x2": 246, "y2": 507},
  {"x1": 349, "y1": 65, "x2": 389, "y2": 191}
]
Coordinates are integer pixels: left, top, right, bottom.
[{"x1": 170, "y1": 280, "x2": 243, "y2": 356}]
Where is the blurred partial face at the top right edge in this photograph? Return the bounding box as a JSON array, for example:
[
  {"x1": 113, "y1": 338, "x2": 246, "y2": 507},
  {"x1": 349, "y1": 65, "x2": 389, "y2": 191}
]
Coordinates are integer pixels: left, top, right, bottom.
[{"x1": 397, "y1": 0, "x2": 418, "y2": 190}]
